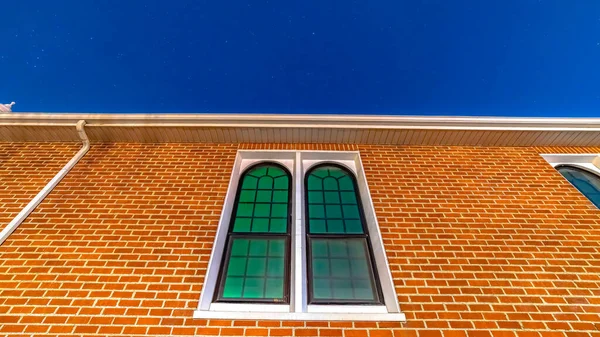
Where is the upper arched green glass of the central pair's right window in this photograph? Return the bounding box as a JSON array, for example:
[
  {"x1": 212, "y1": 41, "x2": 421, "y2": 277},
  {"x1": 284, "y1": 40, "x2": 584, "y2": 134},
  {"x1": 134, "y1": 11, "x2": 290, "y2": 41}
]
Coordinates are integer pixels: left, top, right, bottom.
[{"x1": 306, "y1": 166, "x2": 364, "y2": 234}]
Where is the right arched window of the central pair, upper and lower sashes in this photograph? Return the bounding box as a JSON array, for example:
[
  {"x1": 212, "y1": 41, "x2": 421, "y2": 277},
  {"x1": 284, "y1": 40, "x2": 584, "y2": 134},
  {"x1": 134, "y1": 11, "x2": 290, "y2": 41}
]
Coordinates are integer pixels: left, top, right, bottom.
[{"x1": 305, "y1": 163, "x2": 383, "y2": 304}]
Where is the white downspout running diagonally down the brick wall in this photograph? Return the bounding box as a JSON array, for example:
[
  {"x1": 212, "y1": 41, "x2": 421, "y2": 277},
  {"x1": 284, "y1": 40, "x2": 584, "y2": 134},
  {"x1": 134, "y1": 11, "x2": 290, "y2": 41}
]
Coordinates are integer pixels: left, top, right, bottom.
[{"x1": 0, "y1": 120, "x2": 90, "y2": 245}]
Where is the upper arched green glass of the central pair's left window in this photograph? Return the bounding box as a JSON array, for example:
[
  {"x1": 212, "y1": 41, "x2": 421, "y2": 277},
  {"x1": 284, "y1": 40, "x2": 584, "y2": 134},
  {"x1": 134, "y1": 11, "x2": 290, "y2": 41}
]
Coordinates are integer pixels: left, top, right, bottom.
[{"x1": 232, "y1": 165, "x2": 290, "y2": 233}]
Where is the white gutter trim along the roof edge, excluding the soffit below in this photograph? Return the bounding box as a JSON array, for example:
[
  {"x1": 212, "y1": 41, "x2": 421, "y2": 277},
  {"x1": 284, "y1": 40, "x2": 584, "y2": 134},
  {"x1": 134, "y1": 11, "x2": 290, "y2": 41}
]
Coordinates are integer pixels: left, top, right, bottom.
[{"x1": 5, "y1": 112, "x2": 600, "y2": 131}]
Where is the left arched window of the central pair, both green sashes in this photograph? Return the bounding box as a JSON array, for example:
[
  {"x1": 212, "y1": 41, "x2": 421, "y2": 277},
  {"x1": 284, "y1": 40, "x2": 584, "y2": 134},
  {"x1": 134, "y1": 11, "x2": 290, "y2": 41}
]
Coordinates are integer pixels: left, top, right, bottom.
[{"x1": 215, "y1": 163, "x2": 292, "y2": 303}]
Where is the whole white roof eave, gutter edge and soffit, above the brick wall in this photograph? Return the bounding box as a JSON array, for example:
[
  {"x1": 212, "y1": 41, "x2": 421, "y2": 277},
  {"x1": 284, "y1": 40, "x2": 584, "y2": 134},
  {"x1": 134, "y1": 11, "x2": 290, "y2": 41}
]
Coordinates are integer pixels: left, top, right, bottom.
[{"x1": 0, "y1": 112, "x2": 600, "y2": 146}]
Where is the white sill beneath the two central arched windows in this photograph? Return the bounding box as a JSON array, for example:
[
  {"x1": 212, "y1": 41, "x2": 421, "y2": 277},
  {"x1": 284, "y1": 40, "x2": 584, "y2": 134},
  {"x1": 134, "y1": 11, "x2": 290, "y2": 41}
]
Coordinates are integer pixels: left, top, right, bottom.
[{"x1": 193, "y1": 310, "x2": 406, "y2": 322}]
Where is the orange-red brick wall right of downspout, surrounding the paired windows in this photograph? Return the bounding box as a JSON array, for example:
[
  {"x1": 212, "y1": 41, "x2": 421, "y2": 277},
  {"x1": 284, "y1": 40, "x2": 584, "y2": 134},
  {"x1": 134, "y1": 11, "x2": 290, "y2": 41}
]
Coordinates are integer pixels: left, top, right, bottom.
[{"x1": 0, "y1": 144, "x2": 600, "y2": 337}]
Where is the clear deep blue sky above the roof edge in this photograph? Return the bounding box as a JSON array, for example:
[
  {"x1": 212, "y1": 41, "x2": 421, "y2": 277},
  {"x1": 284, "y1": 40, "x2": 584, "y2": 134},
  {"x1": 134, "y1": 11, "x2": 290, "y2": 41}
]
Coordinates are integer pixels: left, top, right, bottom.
[{"x1": 0, "y1": 0, "x2": 600, "y2": 116}]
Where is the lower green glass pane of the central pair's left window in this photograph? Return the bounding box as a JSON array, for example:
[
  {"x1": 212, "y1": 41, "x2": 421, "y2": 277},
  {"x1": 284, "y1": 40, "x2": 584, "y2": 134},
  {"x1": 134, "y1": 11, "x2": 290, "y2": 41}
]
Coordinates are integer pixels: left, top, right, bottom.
[{"x1": 221, "y1": 238, "x2": 286, "y2": 301}]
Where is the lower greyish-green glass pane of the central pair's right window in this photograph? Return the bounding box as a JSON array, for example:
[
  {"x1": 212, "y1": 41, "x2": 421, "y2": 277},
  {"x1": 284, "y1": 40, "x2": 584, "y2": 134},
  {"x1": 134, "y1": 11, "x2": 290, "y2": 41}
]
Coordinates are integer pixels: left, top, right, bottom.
[{"x1": 310, "y1": 238, "x2": 377, "y2": 301}]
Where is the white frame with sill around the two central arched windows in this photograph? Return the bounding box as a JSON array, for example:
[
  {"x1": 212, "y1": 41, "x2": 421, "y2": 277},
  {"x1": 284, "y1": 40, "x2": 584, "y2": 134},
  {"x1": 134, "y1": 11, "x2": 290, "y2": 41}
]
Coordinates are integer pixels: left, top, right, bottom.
[{"x1": 194, "y1": 150, "x2": 406, "y2": 322}]
